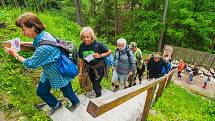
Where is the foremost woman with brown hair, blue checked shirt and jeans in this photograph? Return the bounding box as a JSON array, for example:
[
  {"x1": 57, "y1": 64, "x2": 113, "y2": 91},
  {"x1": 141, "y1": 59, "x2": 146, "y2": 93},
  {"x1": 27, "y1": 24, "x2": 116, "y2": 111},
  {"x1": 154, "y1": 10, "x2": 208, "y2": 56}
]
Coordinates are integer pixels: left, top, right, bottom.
[{"x1": 5, "y1": 13, "x2": 80, "y2": 115}]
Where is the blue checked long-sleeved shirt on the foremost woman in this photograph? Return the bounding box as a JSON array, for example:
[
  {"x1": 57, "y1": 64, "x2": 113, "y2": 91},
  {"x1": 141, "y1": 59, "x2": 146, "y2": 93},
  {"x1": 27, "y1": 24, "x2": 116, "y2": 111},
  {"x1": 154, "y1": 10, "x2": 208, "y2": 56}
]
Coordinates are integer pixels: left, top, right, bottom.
[{"x1": 23, "y1": 31, "x2": 71, "y2": 89}]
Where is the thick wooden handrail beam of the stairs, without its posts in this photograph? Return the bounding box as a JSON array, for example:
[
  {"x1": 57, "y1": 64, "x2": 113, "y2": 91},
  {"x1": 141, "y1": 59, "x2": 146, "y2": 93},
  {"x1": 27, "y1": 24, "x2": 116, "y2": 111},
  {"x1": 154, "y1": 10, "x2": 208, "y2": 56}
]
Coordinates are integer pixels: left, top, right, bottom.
[{"x1": 87, "y1": 77, "x2": 166, "y2": 117}]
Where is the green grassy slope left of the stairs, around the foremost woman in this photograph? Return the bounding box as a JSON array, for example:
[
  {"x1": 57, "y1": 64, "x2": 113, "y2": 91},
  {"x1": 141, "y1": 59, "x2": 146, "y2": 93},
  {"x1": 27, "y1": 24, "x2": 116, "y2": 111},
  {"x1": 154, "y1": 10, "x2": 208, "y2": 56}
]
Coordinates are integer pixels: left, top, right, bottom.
[{"x1": 0, "y1": 9, "x2": 82, "y2": 121}]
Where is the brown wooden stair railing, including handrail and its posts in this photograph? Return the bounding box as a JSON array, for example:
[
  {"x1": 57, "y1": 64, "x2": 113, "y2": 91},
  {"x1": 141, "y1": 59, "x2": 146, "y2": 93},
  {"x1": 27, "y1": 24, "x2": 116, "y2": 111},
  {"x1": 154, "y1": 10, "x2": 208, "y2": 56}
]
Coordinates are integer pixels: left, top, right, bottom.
[{"x1": 87, "y1": 70, "x2": 174, "y2": 121}]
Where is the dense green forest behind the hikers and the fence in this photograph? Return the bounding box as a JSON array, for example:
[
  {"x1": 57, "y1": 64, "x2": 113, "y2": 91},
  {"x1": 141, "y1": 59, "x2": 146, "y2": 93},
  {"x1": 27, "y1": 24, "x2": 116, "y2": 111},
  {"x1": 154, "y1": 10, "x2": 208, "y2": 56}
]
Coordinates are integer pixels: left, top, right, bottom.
[{"x1": 1, "y1": 0, "x2": 215, "y2": 53}]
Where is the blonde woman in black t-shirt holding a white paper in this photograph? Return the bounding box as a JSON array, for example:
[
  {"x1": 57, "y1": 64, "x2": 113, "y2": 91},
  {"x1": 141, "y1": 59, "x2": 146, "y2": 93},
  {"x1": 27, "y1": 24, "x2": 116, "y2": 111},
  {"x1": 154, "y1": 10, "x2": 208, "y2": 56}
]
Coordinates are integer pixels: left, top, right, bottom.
[{"x1": 78, "y1": 27, "x2": 111, "y2": 97}]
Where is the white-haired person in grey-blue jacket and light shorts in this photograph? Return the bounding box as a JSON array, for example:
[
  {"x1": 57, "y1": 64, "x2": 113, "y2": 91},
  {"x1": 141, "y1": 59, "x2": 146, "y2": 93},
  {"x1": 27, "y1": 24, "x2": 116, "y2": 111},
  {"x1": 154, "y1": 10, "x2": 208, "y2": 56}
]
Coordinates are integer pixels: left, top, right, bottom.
[{"x1": 112, "y1": 38, "x2": 135, "y2": 91}]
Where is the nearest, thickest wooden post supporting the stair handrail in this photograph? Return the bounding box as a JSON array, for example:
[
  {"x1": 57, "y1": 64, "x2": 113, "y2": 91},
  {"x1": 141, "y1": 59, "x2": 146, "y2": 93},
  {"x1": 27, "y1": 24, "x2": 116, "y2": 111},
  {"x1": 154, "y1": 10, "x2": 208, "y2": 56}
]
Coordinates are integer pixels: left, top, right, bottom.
[{"x1": 141, "y1": 86, "x2": 156, "y2": 121}]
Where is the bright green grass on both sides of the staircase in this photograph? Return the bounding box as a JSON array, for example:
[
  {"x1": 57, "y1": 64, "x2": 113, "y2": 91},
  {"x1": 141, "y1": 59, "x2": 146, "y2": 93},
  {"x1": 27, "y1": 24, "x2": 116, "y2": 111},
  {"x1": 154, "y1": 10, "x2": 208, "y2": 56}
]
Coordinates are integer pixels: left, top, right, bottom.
[{"x1": 0, "y1": 9, "x2": 215, "y2": 121}]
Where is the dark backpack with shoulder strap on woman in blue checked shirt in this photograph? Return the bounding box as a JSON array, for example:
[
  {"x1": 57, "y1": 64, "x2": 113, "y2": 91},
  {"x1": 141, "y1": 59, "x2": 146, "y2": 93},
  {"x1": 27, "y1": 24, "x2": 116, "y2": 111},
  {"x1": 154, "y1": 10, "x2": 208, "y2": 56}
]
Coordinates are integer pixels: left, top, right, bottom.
[{"x1": 39, "y1": 38, "x2": 78, "y2": 65}]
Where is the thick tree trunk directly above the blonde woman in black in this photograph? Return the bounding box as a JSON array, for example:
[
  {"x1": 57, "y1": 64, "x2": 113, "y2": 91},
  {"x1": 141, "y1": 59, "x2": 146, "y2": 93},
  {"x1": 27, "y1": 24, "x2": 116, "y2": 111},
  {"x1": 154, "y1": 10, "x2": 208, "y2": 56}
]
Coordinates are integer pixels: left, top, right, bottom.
[{"x1": 74, "y1": 0, "x2": 83, "y2": 26}]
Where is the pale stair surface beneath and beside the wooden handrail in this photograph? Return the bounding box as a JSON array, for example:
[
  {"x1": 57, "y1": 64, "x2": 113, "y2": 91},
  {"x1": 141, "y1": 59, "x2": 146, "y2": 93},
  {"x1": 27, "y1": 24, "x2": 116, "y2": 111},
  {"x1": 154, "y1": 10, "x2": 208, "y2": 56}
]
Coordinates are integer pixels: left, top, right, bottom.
[{"x1": 51, "y1": 90, "x2": 146, "y2": 121}]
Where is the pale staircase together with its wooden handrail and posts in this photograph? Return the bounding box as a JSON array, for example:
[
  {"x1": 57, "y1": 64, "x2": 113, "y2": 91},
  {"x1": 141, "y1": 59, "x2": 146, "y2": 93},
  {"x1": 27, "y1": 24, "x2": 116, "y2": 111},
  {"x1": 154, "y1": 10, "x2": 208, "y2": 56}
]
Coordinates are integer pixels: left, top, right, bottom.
[{"x1": 47, "y1": 70, "x2": 174, "y2": 121}]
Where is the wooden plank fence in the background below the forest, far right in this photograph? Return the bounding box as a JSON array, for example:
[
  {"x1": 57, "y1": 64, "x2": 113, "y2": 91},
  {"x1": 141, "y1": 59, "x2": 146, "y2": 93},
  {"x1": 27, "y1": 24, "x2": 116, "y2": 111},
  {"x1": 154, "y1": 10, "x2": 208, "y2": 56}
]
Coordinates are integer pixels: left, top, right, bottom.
[{"x1": 168, "y1": 45, "x2": 215, "y2": 69}]
